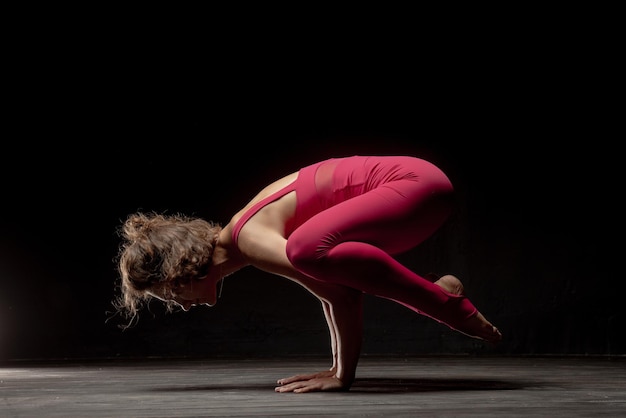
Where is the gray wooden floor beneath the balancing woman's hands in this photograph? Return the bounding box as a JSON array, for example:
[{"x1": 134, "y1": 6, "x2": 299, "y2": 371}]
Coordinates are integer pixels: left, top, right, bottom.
[{"x1": 0, "y1": 357, "x2": 626, "y2": 418}]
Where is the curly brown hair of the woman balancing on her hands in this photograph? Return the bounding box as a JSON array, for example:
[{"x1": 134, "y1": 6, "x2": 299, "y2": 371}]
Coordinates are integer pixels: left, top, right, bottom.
[{"x1": 114, "y1": 212, "x2": 222, "y2": 318}]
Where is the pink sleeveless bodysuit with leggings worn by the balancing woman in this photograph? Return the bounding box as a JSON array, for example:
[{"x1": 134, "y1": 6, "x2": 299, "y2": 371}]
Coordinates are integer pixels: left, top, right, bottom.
[{"x1": 233, "y1": 156, "x2": 477, "y2": 328}]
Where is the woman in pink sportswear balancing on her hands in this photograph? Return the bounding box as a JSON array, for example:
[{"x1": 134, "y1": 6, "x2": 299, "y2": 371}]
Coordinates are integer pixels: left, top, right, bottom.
[{"x1": 118, "y1": 156, "x2": 501, "y2": 393}]
